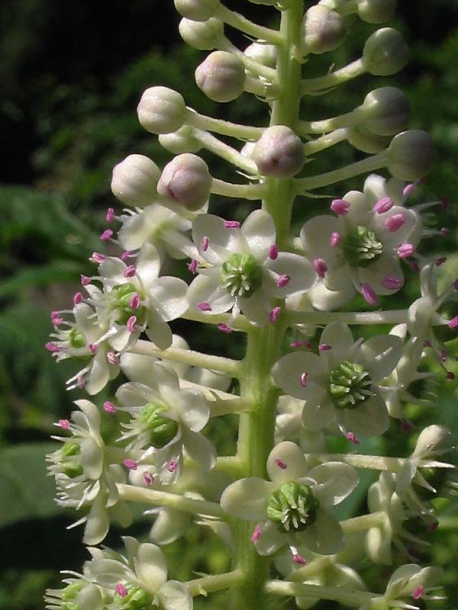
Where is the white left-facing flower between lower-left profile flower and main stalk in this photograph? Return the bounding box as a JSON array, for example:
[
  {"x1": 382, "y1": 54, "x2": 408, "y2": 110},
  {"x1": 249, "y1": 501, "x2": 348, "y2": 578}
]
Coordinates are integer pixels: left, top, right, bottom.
[{"x1": 116, "y1": 363, "x2": 216, "y2": 484}]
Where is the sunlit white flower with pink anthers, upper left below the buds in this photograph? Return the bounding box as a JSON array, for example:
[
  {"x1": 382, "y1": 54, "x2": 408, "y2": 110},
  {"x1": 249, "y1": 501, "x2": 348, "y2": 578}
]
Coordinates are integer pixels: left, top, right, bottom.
[{"x1": 86, "y1": 244, "x2": 188, "y2": 352}]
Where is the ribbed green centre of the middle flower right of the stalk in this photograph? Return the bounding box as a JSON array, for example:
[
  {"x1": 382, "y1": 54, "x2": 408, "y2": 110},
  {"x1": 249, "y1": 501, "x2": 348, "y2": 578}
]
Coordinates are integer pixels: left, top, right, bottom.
[{"x1": 329, "y1": 360, "x2": 373, "y2": 409}]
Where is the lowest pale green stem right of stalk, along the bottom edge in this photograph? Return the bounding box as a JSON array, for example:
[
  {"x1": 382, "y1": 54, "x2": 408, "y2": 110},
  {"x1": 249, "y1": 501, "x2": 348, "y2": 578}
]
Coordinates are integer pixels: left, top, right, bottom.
[{"x1": 265, "y1": 580, "x2": 380, "y2": 608}]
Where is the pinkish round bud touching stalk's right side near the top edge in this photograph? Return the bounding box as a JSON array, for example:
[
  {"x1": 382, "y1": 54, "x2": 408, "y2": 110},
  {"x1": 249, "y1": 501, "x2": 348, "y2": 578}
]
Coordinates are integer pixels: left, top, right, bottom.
[{"x1": 302, "y1": 4, "x2": 346, "y2": 55}]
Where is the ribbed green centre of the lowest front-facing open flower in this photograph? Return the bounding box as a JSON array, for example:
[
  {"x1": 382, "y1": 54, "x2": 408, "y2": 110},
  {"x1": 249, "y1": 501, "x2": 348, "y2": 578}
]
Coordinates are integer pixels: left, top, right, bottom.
[{"x1": 267, "y1": 481, "x2": 320, "y2": 533}]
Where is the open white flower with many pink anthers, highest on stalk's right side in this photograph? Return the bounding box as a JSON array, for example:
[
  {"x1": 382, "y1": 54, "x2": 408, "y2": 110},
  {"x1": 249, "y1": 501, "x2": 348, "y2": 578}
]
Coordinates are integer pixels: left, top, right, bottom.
[{"x1": 300, "y1": 175, "x2": 422, "y2": 309}]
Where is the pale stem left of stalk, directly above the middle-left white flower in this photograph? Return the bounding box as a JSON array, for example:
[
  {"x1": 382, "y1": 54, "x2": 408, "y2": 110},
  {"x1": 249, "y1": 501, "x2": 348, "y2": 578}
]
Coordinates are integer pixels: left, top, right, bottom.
[{"x1": 130, "y1": 340, "x2": 241, "y2": 377}]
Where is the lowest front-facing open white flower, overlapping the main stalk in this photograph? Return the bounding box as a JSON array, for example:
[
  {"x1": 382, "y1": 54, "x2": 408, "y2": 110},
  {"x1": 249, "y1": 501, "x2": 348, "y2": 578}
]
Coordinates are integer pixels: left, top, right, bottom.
[{"x1": 221, "y1": 441, "x2": 358, "y2": 559}]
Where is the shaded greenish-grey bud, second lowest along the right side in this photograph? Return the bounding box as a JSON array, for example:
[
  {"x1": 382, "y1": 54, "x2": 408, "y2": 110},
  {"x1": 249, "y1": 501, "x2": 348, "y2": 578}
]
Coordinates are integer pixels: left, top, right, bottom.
[{"x1": 363, "y1": 87, "x2": 409, "y2": 136}]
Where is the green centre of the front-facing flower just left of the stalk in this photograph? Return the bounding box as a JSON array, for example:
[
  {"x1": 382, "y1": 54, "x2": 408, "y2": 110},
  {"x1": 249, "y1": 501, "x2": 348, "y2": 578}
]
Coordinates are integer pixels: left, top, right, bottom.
[{"x1": 221, "y1": 254, "x2": 262, "y2": 297}]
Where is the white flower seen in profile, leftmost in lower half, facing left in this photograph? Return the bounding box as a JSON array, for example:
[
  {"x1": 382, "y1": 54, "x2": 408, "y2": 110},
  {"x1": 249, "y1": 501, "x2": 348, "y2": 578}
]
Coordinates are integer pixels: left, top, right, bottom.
[{"x1": 46, "y1": 400, "x2": 131, "y2": 544}]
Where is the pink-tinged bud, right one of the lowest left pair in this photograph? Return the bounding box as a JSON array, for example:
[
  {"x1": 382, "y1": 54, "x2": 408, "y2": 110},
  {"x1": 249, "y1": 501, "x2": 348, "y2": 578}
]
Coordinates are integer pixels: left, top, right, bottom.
[{"x1": 157, "y1": 153, "x2": 212, "y2": 211}]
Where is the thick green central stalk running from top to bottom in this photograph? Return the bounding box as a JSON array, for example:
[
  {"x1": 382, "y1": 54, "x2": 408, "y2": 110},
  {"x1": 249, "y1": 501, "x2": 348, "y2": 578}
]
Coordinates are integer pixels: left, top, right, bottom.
[{"x1": 232, "y1": 0, "x2": 303, "y2": 610}]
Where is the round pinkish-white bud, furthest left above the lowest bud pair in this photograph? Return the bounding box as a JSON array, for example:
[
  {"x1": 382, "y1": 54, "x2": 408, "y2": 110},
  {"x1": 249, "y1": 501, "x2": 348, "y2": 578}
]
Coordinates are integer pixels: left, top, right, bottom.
[{"x1": 137, "y1": 87, "x2": 188, "y2": 134}]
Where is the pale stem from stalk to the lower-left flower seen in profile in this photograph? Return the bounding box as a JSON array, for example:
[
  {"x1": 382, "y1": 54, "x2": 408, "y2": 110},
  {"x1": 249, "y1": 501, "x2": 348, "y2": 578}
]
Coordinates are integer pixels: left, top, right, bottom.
[{"x1": 117, "y1": 483, "x2": 227, "y2": 520}]
